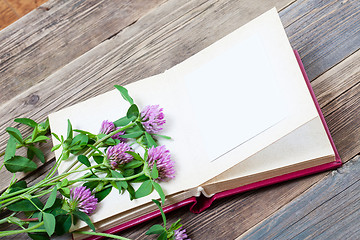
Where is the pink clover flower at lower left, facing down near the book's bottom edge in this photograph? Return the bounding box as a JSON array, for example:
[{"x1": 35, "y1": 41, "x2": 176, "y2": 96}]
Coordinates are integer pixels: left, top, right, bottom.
[{"x1": 69, "y1": 186, "x2": 98, "y2": 215}]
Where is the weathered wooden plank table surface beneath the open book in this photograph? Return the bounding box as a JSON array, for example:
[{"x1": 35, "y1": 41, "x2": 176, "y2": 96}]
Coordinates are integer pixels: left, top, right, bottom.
[{"x1": 0, "y1": 0, "x2": 360, "y2": 239}]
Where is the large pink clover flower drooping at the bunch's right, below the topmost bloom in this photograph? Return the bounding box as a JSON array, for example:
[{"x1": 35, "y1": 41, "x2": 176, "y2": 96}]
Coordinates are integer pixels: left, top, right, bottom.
[{"x1": 147, "y1": 146, "x2": 175, "y2": 181}]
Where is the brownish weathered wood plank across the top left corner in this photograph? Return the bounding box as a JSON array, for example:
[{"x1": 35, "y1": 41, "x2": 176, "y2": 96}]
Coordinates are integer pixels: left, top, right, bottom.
[{"x1": 0, "y1": 0, "x2": 164, "y2": 105}]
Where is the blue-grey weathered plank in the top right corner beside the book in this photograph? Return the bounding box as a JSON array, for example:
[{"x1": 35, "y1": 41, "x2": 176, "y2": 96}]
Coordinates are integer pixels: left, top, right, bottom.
[{"x1": 280, "y1": 0, "x2": 360, "y2": 80}]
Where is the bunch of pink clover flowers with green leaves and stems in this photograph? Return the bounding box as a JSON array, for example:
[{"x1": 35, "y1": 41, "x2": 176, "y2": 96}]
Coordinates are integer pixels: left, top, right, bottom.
[{"x1": 0, "y1": 85, "x2": 187, "y2": 240}]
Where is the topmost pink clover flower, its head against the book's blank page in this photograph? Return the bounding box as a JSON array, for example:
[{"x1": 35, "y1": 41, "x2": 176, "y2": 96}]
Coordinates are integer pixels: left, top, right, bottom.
[{"x1": 140, "y1": 105, "x2": 166, "y2": 133}]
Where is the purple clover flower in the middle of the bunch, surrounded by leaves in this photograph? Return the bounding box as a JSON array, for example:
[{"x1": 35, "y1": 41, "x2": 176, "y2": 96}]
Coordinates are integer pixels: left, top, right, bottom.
[{"x1": 106, "y1": 142, "x2": 133, "y2": 169}]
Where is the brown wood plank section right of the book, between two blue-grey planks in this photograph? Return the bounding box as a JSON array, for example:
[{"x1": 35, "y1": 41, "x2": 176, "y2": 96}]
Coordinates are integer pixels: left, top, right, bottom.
[{"x1": 312, "y1": 50, "x2": 360, "y2": 161}]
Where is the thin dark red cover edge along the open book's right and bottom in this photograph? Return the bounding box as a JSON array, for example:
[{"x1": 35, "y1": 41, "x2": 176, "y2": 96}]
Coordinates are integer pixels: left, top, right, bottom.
[{"x1": 86, "y1": 50, "x2": 342, "y2": 240}]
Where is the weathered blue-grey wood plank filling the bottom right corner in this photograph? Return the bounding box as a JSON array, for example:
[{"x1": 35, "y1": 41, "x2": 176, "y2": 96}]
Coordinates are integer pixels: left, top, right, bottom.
[{"x1": 238, "y1": 157, "x2": 360, "y2": 240}]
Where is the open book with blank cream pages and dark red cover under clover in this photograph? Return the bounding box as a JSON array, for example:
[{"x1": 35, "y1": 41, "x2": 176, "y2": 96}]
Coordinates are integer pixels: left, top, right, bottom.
[{"x1": 49, "y1": 9, "x2": 341, "y2": 239}]
